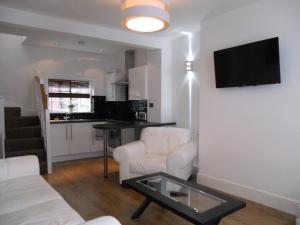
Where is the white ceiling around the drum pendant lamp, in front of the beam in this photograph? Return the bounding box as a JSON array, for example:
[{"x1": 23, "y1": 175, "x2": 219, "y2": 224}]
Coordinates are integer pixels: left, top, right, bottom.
[{"x1": 0, "y1": 0, "x2": 260, "y2": 37}]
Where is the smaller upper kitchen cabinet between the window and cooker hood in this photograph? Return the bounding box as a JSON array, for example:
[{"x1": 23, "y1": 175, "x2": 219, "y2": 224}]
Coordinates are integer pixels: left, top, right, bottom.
[{"x1": 105, "y1": 72, "x2": 126, "y2": 102}]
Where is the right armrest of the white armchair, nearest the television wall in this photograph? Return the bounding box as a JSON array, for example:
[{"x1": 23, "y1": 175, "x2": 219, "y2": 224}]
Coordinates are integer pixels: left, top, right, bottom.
[{"x1": 167, "y1": 141, "x2": 197, "y2": 169}]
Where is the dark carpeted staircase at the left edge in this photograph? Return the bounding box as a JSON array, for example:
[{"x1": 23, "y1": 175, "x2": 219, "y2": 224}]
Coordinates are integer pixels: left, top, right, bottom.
[{"x1": 4, "y1": 107, "x2": 47, "y2": 174}]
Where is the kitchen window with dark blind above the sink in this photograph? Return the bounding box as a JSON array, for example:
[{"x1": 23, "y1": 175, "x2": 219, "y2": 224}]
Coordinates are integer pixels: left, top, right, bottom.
[{"x1": 48, "y1": 79, "x2": 92, "y2": 113}]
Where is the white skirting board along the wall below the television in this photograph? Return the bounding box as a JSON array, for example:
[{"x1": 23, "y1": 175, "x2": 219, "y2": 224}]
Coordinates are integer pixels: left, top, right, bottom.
[{"x1": 197, "y1": 173, "x2": 300, "y2": 215}]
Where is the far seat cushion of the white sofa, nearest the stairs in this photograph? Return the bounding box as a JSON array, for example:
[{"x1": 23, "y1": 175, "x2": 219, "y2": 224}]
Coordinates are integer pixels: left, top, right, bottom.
[{"x1": 0, "y1": 175, "x2": 62, "y2": 216}]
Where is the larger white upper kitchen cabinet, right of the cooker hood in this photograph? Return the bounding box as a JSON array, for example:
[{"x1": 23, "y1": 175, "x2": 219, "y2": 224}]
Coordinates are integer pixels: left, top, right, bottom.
[{"x1": 128, "y1": 66, "x2": 148, "y2": 100}]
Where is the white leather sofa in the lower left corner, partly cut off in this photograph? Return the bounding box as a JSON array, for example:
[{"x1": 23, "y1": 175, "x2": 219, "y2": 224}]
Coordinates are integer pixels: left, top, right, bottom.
[{"x1": 0, "y1": 156, "x2": 120, "y2": 225}]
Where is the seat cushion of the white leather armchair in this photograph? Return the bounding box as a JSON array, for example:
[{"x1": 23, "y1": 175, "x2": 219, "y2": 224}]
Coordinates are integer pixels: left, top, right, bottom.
[{"x1": 129, "y1": 155, "x2": 167, "y2": 175}]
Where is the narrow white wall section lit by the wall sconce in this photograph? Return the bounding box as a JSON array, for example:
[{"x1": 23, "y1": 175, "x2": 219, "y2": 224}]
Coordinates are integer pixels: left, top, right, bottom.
[{"x1": 171, "y1": 33, "x2": 200, "y2": 141}]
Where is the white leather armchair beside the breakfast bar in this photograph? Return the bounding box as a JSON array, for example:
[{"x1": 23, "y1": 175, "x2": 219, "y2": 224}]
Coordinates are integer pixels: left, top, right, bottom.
[{"x1": 114, "y1": 127, "x2": 197, "y2": 184}]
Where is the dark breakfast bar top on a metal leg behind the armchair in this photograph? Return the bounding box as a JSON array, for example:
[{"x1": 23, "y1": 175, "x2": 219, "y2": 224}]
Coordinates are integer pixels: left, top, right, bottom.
[{"x1": 93, "y1": 121, "x2": 176, "y2": 130}]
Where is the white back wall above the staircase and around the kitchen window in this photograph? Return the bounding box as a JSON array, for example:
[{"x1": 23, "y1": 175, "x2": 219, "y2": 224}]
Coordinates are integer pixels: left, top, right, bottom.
[{"x1": 0, "y1": 34, "x2": 124, "y2": 114}]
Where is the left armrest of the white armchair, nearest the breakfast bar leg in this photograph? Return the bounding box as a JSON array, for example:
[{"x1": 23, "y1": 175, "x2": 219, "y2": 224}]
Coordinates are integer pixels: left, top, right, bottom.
[{"x1": 113, "y1": 141, "x2": 146, "y2": 184}]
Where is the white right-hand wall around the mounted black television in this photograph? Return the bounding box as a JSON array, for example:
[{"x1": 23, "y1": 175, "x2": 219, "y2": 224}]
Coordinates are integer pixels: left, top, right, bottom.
[{"x1": 198, "y1": 0, "x2": 300, "y2": 213}]
